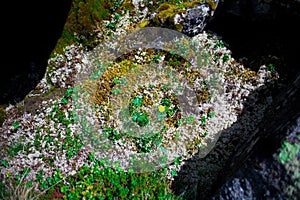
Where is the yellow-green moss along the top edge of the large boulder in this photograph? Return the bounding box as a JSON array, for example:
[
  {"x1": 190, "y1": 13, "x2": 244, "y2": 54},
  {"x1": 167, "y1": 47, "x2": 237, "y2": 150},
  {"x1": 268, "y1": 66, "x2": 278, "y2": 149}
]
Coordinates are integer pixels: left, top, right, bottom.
[{"x1": 51, "y1": 0, "x2": 217, "y2": 57}]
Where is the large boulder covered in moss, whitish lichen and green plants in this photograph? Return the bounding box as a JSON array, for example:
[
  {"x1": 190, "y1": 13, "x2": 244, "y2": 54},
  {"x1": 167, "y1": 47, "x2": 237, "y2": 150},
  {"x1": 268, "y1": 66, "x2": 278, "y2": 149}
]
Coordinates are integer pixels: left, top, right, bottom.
[{"x1": 0, "y1": 0, "x2": 300, "y2": 199}]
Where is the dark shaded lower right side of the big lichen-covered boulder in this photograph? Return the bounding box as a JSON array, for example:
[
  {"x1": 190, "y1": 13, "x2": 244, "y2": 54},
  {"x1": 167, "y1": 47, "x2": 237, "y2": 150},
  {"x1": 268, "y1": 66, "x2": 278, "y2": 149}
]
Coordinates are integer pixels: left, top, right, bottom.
[{"x1": 171, "y1": 79, "x2": 284, "y2": 200}]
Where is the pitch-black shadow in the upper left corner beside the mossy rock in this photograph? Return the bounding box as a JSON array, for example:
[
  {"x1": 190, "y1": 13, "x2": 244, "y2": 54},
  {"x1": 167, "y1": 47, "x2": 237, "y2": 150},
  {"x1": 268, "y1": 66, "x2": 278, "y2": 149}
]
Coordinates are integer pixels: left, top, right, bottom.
[{"x1": 0, "y1": 0, "x2": 72, "y2": 104}]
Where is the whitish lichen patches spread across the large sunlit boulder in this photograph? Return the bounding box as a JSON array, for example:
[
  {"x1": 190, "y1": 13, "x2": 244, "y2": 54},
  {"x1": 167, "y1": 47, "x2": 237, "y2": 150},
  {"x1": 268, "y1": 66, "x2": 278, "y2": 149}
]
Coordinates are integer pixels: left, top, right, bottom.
[{"x1": 0, "y1": 1, "x2": 278, "y2": 197}]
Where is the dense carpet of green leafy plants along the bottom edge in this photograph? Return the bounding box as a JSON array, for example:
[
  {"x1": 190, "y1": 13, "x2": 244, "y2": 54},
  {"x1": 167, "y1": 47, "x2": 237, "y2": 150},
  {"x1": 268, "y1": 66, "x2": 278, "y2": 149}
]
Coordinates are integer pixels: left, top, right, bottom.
[{"x1": 30, "y1": 153, "x2": 181, "y2": 200}]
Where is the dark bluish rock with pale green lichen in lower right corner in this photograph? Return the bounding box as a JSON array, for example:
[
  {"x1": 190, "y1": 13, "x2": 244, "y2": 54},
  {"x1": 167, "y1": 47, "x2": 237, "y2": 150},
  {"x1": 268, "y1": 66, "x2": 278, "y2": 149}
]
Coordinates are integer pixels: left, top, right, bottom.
[{"x1": 212, "y1": 118, "x2": 300, "y2": 200}]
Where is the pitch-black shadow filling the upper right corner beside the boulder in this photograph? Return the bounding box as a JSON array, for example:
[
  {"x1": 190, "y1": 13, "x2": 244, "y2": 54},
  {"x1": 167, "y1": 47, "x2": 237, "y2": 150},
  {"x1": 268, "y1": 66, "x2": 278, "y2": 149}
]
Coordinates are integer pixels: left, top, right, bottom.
[{"x1": 205, "y1": 0, "x2": 300, "y2": 81}]
